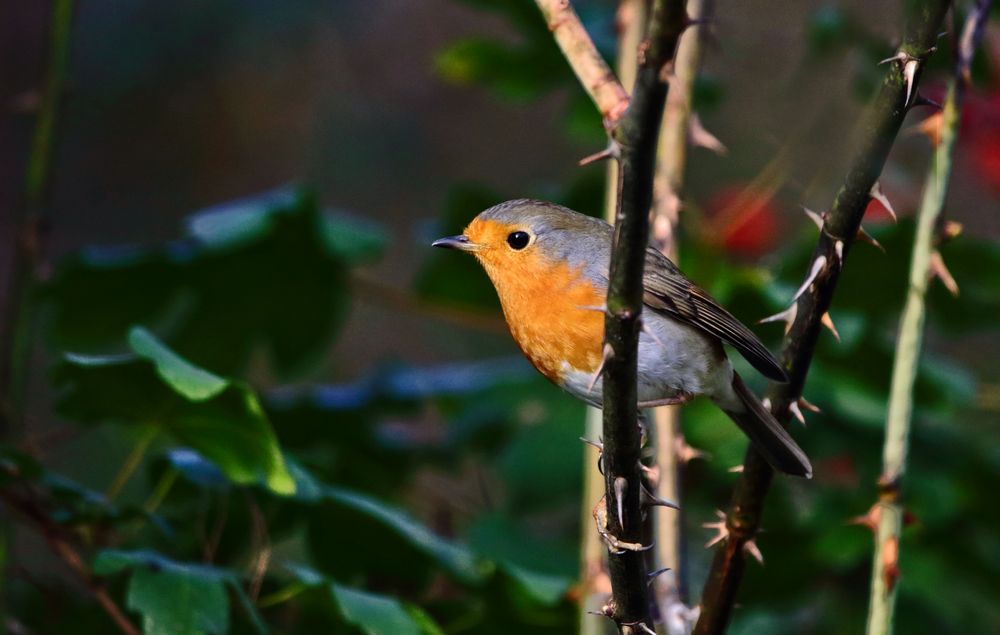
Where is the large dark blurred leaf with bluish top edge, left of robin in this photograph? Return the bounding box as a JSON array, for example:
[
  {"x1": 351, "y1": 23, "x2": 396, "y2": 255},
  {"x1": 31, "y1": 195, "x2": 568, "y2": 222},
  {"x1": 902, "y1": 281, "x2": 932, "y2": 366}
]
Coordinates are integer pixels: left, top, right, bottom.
[{"x1": 45, "y1": 190, "x2": 384, "y2": 374}]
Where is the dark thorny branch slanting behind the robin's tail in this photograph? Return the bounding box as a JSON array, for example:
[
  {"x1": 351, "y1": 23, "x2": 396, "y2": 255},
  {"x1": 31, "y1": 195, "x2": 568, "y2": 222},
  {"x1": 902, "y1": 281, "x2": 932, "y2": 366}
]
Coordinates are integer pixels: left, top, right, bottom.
[{"x1": 694, "y1": 0, "x2": 949, "y2": 635}]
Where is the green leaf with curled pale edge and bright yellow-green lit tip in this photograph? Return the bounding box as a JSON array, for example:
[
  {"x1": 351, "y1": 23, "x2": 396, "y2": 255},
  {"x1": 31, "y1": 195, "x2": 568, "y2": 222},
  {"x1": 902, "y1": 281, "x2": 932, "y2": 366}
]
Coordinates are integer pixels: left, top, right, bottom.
[{"x1": 54, "y1": 328, "x2": 295, "y2": 494}]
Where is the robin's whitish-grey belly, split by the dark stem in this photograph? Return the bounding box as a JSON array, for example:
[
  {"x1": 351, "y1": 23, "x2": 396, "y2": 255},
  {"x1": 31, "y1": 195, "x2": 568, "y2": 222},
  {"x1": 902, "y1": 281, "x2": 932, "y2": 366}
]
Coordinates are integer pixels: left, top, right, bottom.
[{"x1": 562, "y1": 311, "x2": 732, "y2": 406}]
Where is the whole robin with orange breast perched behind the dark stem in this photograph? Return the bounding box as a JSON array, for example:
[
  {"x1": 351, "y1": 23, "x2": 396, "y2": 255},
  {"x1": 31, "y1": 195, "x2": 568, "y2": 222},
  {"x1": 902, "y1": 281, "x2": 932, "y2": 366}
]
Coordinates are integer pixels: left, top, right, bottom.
[{"x1": 433, "y1": 199, "x2": 812, "y2": 478}]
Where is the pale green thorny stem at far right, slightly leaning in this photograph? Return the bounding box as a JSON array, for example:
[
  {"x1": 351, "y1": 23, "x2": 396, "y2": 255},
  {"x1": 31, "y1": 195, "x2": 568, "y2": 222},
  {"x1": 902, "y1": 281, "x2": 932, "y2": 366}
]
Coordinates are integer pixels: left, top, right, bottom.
[{"x1": 867, "y1": 0, "x2": 992, "y2": 635}]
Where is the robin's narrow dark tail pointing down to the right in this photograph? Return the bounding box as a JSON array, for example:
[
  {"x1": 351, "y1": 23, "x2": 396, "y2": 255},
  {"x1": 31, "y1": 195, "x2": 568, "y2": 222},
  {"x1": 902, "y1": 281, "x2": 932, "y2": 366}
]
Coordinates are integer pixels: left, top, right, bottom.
[{"x1": 723, "y1": 371, "x2": 812, "y2": 478}]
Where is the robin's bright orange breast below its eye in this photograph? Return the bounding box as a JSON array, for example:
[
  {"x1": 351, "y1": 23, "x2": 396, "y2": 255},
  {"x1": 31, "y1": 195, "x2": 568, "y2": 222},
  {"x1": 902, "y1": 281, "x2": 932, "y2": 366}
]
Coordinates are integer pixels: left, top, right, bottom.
[{"x1": 483, "y1": 252, "x2": 606, "y2": 384}]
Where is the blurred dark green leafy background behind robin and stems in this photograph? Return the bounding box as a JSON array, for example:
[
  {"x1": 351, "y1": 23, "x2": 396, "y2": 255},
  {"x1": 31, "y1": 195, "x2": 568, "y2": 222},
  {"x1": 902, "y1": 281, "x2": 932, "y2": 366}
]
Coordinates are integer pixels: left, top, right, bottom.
[{"x1": 0, "y1": 0, "x2": 1000, "y2": 633}]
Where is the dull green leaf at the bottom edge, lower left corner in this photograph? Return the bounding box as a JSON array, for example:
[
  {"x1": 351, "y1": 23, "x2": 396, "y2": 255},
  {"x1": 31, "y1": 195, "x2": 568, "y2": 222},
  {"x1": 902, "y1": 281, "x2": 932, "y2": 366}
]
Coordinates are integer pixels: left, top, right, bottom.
[{"x1": 93, "y1": 550, "x2": 229, "y2": 635}]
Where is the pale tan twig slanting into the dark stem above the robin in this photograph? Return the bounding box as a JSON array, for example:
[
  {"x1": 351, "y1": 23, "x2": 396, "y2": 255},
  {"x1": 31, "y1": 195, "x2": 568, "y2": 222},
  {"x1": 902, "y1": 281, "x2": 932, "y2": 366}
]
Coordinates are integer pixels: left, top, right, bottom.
[{"x1": 535, "y1": 0, "x2": 628, "y2": 125}]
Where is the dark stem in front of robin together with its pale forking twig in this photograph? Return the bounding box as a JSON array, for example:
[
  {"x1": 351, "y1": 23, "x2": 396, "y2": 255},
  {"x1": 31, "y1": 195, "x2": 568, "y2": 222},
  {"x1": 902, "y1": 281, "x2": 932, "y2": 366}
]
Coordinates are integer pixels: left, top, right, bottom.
[{"x1": 536, "y1": 0, "x2": 690, "y2": 633}]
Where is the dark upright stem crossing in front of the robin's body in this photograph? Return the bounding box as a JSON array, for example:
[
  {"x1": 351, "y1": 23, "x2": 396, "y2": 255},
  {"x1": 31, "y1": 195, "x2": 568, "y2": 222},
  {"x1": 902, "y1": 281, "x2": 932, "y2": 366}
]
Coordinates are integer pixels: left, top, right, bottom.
[{"x1": 603, "y1": 0, "x2": 688, "y2": 633}]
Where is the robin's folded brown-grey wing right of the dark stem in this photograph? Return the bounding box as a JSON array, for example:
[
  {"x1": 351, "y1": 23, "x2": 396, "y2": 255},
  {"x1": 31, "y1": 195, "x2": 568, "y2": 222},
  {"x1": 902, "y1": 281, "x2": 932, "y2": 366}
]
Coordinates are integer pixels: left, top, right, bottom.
[{"x1": 643, "y1": 248, "x2": 788, "y2": 381}]
